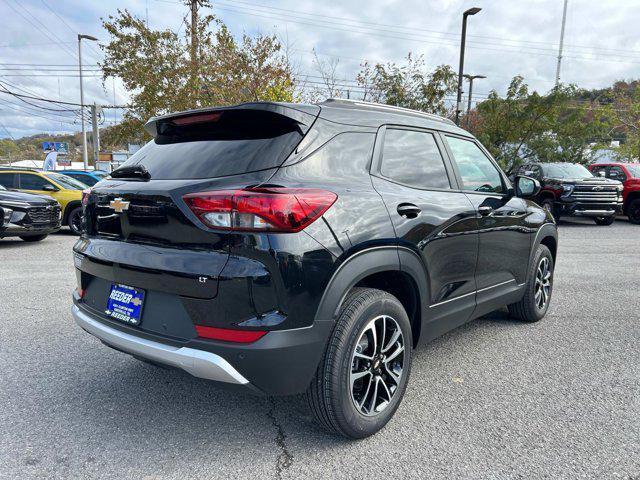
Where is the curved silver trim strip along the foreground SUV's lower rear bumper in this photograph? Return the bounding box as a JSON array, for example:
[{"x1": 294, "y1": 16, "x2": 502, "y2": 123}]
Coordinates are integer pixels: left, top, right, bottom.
[{"x1": 71, "y1": 305, "x2": 249, "y2": 385}]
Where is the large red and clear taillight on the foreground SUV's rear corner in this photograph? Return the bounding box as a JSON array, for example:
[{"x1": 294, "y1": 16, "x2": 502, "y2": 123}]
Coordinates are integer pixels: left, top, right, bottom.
[{"x1": 183, "y1": 187, "x2": 338, "y2": 232}]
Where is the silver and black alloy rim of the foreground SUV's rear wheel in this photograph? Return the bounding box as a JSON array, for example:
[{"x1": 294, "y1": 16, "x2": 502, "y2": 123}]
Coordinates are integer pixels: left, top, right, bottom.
[{"x1": 349, "y1": 315, "x2": 405, "y2": 416}]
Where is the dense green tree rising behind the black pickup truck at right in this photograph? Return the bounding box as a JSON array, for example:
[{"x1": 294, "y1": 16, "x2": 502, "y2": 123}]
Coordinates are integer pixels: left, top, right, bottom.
[{"x1": 471, "y1": 76, "x2": 604, "y2": 171}]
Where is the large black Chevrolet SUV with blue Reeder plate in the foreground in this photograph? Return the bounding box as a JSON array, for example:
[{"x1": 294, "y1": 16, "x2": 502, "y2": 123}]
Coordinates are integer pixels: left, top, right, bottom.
[{"x1": 73, "y1": 100, "x2": 557, "y2": 438}]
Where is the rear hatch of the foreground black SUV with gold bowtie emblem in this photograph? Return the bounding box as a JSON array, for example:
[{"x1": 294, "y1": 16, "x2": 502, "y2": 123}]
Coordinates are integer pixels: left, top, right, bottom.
[{"x1": 74, "y1": 104, "x2": 317, "y2": 338}]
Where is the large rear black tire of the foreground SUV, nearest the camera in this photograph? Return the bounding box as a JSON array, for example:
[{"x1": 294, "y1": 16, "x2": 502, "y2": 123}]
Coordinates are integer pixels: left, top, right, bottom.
[{"x1": 306, "y1": 288, "x2": 413, "y2": 439}]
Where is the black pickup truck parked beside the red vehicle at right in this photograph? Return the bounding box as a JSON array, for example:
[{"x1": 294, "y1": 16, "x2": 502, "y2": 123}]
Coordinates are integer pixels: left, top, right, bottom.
[{"x1": 516, "y1": 162, "x2": 622, "y2": 225}]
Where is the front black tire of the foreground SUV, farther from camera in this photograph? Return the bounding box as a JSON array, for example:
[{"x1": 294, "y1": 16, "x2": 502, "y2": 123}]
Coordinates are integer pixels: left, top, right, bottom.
[{"x1": 509, "y1": 245, "x2": 554, "y2": 322}]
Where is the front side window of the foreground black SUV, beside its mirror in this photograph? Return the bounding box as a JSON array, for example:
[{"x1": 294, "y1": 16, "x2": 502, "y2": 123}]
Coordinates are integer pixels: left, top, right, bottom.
[{"x1": 447, "y1": 136, "x2": 505, "y2": 193}]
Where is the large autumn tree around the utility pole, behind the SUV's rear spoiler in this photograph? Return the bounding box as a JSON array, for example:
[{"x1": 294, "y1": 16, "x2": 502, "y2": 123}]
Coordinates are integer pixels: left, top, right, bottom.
[{"x1": 100, "y1": 6, "x2": 293, "y2": 144}]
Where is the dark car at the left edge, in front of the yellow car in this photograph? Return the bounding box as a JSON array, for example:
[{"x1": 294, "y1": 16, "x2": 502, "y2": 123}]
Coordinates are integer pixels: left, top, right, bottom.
[{"x1": 0, "y1": 185, "x2": 61, "y2": 242}]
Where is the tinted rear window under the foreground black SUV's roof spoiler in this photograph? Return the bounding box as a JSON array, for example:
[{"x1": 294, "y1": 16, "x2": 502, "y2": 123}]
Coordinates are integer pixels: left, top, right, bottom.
[{"x1": 123, "y1": 110, "x2": 303, "y2": 180}]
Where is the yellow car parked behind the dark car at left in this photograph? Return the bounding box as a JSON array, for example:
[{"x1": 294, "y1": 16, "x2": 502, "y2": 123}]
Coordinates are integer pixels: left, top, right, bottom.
[{"x1": 0, "y1": 167, "x2": 88, "y2": 235}]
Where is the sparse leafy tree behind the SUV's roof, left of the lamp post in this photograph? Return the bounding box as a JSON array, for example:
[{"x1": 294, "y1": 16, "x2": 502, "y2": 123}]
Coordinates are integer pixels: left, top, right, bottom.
[{"x1": 356, "y1": 53, "x2": 457, "y2": 115}]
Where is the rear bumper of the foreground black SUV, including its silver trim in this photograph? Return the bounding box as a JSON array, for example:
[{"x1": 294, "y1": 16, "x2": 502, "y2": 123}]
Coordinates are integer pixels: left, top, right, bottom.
[{"x1": 72, "y1": 298, "x2": 333, "y2": 395}]
